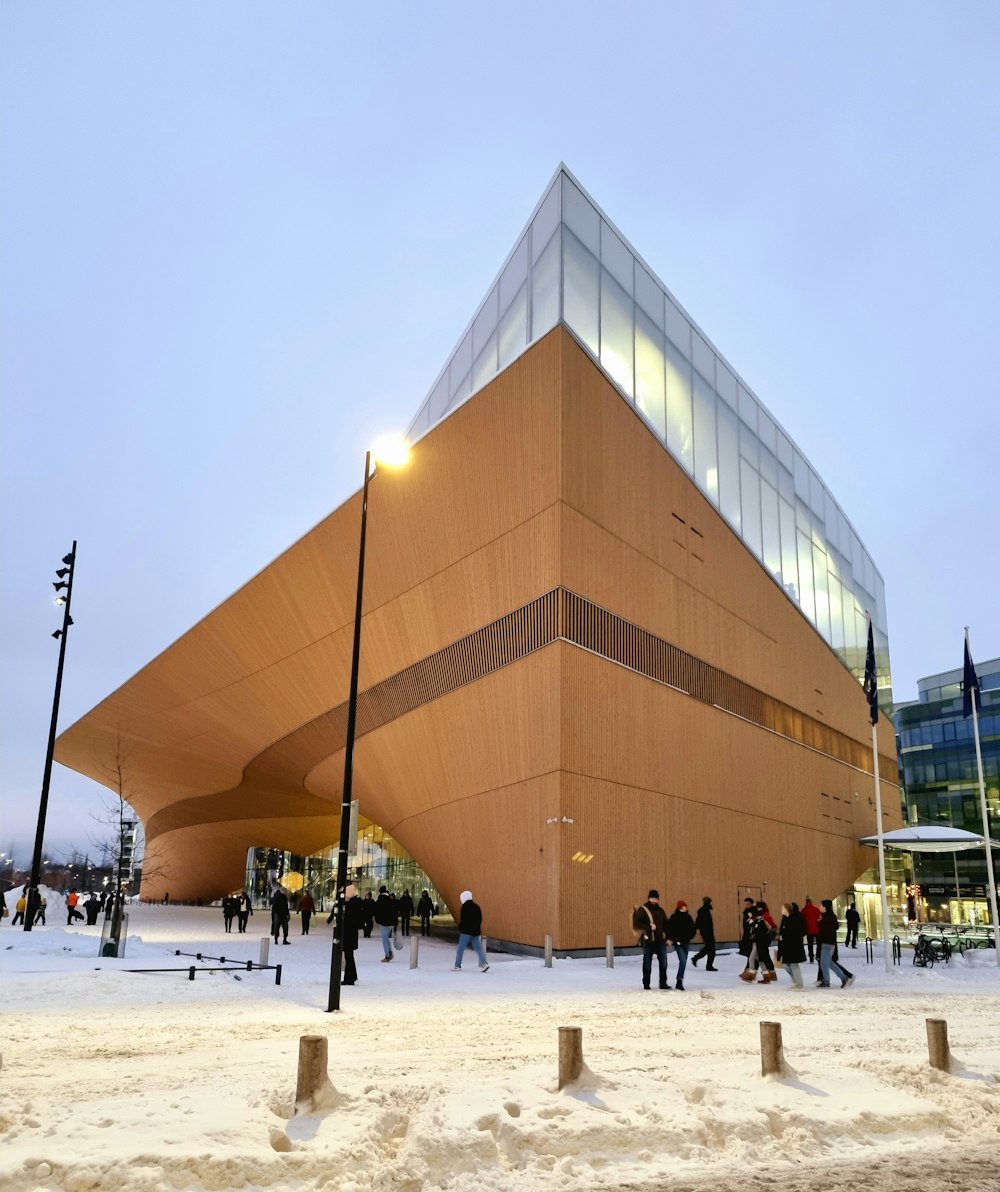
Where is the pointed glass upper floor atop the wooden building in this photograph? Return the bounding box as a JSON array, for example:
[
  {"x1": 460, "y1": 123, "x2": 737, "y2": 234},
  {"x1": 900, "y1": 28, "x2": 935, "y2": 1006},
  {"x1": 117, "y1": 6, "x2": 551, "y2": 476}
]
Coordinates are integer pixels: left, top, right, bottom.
[{"x1": 409, "y1": 166, "x2": 890, "y2": 703}]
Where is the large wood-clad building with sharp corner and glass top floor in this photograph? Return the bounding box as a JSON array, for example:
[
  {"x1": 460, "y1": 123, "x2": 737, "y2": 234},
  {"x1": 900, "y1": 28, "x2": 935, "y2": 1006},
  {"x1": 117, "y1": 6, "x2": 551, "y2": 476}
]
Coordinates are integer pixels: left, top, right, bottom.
[{"x1": 56, "y1": 167, "x2": 900, "y2": 950}]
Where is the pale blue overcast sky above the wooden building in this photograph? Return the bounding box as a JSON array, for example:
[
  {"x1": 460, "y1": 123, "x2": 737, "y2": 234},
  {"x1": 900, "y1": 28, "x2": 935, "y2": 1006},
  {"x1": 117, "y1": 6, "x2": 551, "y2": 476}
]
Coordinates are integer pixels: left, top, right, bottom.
[{"x1": 0, "y1": 0, "x2": 1000, "y2": 862}]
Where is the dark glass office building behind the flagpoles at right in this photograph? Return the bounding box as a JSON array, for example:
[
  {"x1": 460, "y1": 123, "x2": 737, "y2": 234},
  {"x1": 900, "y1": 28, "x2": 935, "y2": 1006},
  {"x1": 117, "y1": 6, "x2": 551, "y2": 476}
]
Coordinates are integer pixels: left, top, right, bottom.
[{"x1": 893, "y1": 658, "x2": 1000, "y2": 923}]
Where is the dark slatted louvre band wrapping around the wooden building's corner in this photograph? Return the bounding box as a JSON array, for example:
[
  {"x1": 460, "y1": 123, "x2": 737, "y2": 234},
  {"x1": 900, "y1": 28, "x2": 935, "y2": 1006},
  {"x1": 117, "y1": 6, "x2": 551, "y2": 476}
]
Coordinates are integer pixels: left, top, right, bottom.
[{"x1": 286, "y1": 588, "x2": 896, "y2": 772}]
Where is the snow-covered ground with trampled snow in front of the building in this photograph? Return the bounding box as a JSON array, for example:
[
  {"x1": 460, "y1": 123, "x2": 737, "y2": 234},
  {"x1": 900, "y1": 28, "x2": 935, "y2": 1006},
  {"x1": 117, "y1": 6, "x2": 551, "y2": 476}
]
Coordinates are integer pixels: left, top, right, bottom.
[{"x1": 0, "y1": 898, "x2": 1000, "y2": 1192}]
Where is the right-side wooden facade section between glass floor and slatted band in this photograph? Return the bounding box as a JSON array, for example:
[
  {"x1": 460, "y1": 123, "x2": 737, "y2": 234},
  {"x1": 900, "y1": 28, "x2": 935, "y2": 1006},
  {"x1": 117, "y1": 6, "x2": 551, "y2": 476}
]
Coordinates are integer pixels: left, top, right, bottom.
[{"x1": 563, "y1": 336, "x2": 895, "y2": 759}]
